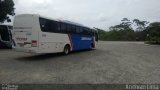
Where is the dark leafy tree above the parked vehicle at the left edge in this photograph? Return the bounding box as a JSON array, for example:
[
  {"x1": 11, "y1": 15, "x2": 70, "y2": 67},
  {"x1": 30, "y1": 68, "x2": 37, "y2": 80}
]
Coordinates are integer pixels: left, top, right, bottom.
[{"x1": 0, "y1": 0, "x2": 15, "y2": 23}]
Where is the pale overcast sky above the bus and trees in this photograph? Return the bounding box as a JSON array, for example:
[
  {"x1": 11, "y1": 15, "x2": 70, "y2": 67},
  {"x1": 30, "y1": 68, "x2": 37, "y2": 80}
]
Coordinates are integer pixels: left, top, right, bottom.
[{"x1": 10, "y1": 0, "x2": 160, "y2": 30}]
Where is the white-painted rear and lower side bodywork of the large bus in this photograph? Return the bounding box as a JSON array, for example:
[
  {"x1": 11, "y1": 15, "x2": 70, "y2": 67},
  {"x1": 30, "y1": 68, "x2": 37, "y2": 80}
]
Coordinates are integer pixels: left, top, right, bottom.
[{"x1": 13, "y1": 14, "x2": 97, "y2": 53}]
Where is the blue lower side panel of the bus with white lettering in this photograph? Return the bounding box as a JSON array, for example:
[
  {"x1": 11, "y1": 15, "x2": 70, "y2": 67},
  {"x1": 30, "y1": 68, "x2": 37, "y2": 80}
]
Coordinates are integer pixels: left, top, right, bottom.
[{"x1": 71, "y1": 34, "x2": 94, "y2": 50}]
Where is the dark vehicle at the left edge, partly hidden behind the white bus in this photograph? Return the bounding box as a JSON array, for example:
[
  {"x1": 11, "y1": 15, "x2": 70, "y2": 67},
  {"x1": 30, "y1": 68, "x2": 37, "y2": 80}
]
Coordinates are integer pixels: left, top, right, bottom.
[{"x1": 0, "y1": 25, "x2": 13, "y2": 49}]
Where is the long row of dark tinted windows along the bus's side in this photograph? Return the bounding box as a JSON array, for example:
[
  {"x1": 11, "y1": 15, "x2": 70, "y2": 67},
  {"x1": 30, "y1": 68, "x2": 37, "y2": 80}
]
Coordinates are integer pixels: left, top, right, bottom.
[{"x1": 39, "y1": 18, "x2": 93, "y2": 35}]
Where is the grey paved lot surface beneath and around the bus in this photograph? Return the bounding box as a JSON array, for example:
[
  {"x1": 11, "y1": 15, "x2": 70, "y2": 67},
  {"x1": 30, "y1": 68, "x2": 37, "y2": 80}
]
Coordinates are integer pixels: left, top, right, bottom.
[{"x1": 0, "y1": 42, "x2": 160, "y2": 84}]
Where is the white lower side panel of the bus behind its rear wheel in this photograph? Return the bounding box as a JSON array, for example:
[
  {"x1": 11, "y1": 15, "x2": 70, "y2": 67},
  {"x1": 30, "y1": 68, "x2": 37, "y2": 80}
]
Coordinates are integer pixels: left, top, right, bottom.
[{"x1": 39, "y1": 32, "x2": 70, "y2": 53}]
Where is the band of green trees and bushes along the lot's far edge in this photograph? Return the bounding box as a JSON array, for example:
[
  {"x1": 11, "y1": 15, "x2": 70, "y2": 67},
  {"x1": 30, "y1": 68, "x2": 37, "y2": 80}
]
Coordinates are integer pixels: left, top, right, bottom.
[{"x1": 96, "y1": 18, "x2": 160, "y2": 44}]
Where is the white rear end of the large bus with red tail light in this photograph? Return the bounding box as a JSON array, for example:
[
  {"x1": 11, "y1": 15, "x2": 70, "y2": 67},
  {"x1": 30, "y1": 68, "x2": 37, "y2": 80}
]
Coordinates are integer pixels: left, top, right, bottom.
[{"x1": 13, "y1": 14, "x2": 40, "y2": 53}]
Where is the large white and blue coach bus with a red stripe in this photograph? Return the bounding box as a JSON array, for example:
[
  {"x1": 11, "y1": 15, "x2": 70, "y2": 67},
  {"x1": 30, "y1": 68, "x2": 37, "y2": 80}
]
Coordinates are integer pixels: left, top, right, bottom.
[{"x1": 13, "y1": 14, "x2": 98, "y2": 55}]
